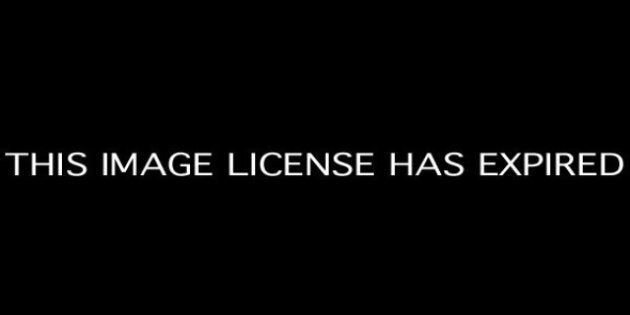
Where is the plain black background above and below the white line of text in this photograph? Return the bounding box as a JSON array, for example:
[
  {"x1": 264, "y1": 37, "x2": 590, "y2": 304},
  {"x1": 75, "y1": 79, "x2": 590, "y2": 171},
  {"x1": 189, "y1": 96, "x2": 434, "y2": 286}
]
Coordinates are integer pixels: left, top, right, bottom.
[{"x1": 0, "y1": 3, "x2": 628, "y2": 309}]
